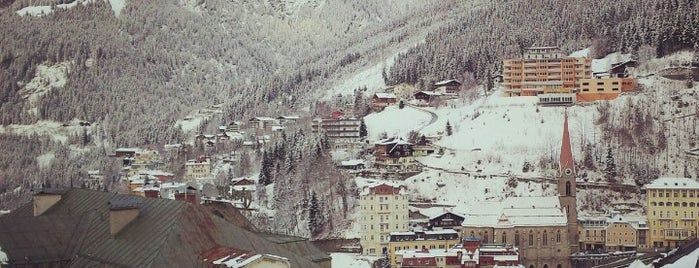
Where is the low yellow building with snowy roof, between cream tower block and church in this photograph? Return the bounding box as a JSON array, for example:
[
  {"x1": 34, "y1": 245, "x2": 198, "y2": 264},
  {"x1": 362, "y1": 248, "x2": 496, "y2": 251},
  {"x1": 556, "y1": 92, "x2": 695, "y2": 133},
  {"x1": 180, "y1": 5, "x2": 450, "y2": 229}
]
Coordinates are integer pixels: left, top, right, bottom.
[{"x1": 388, "y1": 229, "x2": 460, "y2": 267}]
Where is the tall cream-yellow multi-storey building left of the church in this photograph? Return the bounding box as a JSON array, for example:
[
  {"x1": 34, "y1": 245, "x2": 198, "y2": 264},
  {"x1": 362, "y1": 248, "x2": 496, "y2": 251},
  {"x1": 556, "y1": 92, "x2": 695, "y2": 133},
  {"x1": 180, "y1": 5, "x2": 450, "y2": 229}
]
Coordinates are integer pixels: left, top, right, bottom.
[{"x1": 359, "y1": 183, "x2": 409, "y2": 256}]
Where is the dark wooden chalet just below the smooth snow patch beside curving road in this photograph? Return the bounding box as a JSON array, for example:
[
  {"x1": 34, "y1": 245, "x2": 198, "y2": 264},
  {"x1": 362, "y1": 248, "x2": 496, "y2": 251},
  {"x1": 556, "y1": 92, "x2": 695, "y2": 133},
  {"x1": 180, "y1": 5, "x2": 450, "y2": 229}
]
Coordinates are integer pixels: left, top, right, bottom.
[{"x1": 374, "y1": 137, "x2": 415, "y2": 172}]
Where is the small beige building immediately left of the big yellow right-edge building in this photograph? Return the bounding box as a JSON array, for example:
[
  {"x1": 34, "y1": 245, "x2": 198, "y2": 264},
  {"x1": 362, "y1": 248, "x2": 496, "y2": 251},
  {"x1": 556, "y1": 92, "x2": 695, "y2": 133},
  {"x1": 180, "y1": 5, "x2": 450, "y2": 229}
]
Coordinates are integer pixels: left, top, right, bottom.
[{"x1": 604, "y1": 215, "x2": 648, "y2": 251}]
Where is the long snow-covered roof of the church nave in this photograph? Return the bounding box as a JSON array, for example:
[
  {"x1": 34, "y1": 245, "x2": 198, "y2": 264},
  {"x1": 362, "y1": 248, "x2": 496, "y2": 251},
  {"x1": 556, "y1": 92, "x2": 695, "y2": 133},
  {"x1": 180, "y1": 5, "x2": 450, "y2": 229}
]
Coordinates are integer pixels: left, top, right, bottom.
[{"x1": 461, "y1": 196, "x2": 567, "y2": 228}]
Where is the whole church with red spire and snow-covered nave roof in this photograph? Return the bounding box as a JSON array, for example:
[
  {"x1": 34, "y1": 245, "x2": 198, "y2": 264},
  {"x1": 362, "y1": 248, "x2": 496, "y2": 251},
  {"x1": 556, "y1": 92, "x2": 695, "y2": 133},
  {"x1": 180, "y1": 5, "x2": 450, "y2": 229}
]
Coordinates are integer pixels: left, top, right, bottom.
[{"x1": 461, "y1": 113, "x2": 579, "y2": 268}]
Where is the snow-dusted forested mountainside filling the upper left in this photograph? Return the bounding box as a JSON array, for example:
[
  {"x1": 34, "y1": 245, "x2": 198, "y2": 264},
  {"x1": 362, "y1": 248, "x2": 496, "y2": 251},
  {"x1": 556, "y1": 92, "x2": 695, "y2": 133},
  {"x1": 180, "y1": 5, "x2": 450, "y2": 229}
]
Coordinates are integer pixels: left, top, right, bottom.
[{"x1": 0, "y1": 0, "x2": 446, "y2": 207}]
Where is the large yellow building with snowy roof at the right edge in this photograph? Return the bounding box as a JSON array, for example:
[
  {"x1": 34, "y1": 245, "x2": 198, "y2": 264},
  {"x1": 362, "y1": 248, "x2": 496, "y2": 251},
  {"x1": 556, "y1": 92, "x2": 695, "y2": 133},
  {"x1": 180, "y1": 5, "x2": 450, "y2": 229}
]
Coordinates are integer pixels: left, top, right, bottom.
[{"x1": 643, "y1": 178, "x2": 699, "y2": 248}]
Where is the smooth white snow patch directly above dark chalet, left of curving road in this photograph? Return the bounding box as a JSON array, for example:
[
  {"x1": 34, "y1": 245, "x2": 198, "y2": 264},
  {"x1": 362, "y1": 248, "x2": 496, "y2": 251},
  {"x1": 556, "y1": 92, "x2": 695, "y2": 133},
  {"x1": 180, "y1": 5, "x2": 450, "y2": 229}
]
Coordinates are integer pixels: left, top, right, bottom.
[{"x1": 364, "y1": 105, "x2": 432, "y2": 140}]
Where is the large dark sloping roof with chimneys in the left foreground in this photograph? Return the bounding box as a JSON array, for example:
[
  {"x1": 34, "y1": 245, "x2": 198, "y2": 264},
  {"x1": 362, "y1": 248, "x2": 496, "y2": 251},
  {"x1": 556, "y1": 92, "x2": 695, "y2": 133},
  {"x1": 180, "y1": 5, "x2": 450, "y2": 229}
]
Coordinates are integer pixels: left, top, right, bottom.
[{"x1": 0, "y1": 189, "x2": 329, "y2": 268}]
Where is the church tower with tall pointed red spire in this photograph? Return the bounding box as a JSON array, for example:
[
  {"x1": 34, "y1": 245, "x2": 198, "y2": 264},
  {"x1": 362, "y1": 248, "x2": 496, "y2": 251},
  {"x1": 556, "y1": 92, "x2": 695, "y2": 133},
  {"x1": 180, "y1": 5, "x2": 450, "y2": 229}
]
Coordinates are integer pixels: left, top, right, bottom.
[{"x1": 558, "y1": 111, "x2": 580, "y2": 253}]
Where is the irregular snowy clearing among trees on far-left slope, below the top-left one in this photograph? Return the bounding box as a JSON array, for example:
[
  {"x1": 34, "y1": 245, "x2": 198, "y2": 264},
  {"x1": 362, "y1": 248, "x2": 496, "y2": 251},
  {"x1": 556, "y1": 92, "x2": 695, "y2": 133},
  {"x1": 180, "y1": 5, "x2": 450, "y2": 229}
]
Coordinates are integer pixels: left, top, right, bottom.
[{"x1": 19, "y1": 61, "x2": 72, "y2": 115}]
